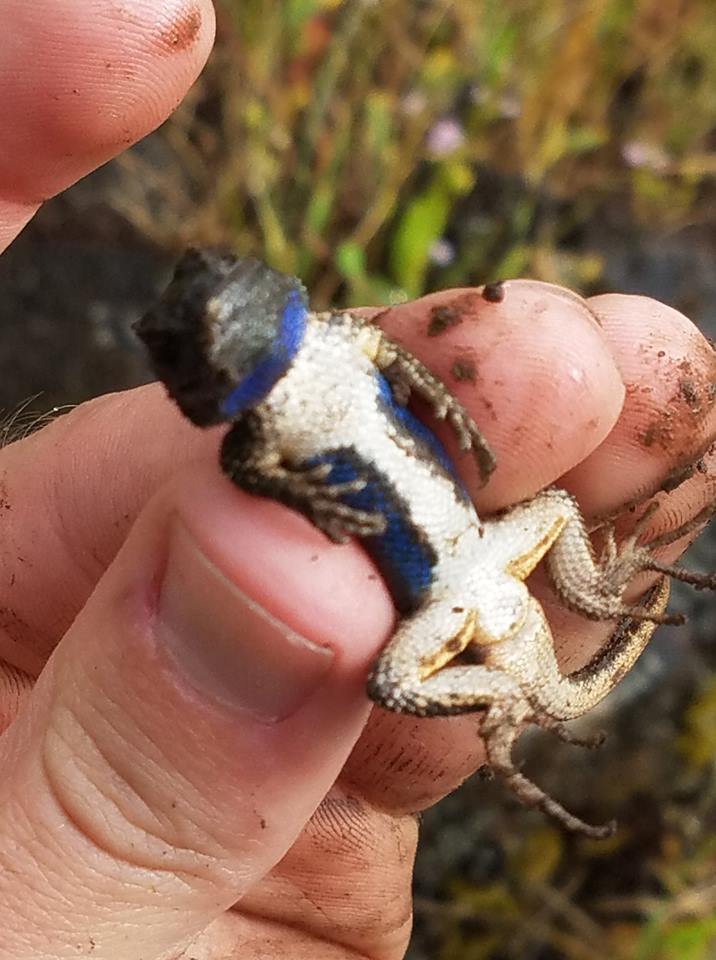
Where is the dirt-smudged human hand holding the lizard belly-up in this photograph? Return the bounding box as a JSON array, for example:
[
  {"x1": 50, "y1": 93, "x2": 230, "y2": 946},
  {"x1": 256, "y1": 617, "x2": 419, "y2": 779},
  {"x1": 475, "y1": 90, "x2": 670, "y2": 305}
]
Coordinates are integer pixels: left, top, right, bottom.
[{"x1": 0, "y1": 0, "x2": 714, "y2": 960}]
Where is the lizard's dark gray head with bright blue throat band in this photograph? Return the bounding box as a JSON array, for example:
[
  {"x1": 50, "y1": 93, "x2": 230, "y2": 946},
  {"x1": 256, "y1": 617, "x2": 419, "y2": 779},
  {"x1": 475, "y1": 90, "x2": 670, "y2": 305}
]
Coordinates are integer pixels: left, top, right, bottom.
[{"x1": 135, "y1": 250, "x2": 308, "y2": 426}]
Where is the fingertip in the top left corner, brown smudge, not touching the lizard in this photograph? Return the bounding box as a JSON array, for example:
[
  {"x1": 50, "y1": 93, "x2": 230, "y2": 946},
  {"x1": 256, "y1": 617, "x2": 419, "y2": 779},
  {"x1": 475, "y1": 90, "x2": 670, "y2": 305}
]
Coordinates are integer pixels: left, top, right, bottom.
[{"x1": 0, "y1": 0, "x2": 214, "y2": 205}]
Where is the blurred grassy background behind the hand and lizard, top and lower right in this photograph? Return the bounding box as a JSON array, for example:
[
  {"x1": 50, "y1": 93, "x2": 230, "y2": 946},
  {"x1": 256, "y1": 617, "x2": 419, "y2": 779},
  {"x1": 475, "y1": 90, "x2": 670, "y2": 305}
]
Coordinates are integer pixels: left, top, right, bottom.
[{"x1": 0, "y1": 0, "x2": 716, "y2": 960}]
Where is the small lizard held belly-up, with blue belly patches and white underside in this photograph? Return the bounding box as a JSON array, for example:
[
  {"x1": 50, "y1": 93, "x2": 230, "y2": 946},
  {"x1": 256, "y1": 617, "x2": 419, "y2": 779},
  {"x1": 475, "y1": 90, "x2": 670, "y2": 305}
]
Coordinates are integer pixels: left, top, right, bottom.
[{"x1": 137, "y1": 251, "x2": 713, "y2": 836}]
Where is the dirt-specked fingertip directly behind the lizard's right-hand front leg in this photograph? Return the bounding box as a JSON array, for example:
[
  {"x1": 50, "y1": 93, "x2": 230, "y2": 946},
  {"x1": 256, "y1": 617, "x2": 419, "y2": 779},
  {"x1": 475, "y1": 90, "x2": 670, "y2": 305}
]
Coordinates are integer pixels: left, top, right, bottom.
[{"x1": 380, "y1": 281, "x2": 624, "y2": 510}]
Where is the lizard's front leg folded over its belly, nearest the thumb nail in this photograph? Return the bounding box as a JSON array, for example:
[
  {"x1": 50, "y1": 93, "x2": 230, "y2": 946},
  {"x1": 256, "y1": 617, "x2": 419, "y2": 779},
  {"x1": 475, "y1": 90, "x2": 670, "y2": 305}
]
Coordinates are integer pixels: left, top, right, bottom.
[{"x1": 220, "y1": 410, "x2": 386, "y2": 543}]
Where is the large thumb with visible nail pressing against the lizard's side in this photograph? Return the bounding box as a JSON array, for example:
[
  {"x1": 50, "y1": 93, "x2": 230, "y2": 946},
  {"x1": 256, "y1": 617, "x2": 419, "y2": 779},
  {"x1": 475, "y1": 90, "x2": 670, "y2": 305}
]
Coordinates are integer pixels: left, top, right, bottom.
[{"x1": 0, "y1": 465, "x2": 392, "y2": 960}]
